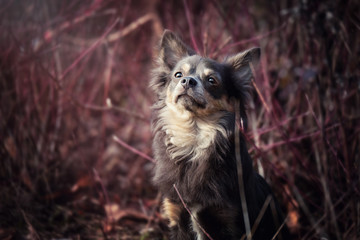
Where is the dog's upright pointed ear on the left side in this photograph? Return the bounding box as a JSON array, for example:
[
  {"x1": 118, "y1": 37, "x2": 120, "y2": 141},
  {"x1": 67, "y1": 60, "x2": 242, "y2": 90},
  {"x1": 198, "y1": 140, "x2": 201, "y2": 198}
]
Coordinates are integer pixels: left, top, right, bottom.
[{"x1": 159, "y1": 30, "x2": 196, "y2": 69}]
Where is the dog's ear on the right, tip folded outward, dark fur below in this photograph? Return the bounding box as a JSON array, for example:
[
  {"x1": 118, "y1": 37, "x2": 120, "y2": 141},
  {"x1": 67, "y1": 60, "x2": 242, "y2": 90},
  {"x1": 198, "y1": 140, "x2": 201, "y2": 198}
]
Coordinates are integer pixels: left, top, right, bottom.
[{"x1": 225, "y1": 48, "x2": 260, "y2": 100}]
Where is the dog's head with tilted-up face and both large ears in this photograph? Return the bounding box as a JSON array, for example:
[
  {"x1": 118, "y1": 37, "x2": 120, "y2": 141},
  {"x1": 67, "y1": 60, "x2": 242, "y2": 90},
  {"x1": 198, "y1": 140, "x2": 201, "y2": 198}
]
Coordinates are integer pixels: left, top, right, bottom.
[{"x1": 151, "y1": 30, "x2": 260, "y2": 119}]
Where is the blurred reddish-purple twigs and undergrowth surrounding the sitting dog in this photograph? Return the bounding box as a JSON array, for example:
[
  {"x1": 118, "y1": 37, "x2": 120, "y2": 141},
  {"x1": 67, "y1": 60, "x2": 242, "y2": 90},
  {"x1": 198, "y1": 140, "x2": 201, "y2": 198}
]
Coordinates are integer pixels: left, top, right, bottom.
[{"x1": 0, "y1": 0, "x2": 360, "y2": 240}]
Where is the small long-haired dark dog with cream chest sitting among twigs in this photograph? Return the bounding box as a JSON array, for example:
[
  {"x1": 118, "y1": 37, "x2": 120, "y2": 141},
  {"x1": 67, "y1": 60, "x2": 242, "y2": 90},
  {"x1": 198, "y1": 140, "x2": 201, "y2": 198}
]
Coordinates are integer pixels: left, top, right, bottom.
[{"x1": 150, "y1": 30, "x2": 289, "y2": 240}]
